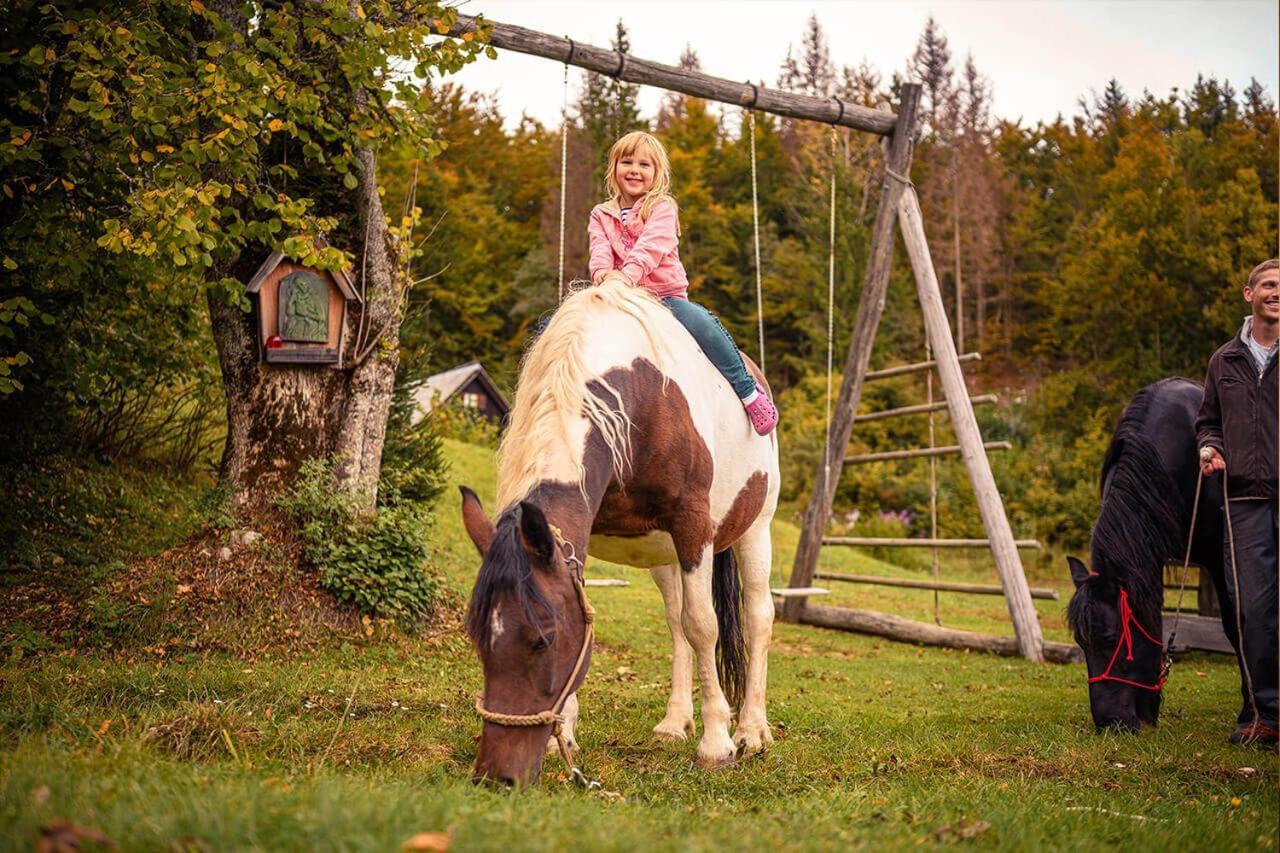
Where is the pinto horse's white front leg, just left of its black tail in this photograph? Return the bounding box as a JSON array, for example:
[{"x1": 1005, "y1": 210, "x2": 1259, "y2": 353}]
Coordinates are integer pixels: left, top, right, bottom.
[{"x1": 680, "y1": 542, "x2": 735, "y2": 767}]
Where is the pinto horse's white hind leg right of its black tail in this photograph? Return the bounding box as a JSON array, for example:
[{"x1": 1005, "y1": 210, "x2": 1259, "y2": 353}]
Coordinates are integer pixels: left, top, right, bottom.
[{"x1": 733, "y1": 519, "x2": 773, "y2": 752}]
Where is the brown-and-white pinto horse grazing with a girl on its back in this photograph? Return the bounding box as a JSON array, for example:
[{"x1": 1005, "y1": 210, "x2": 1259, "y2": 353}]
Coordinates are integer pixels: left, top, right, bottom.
[{"x1": 462, "y1": 277, "x2": 780, "y2": 784}]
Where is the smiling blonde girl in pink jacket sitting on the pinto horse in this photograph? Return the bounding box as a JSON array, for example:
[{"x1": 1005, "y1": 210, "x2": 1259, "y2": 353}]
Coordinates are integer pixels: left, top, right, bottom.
[{"x1": 588, "y1": 131, "x2": 778, "y2": 435}]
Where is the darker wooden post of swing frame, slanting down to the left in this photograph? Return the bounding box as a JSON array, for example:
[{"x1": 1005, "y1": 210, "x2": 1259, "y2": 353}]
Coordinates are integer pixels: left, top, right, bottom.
[{"x1": 782, "y1": 83, "x2": 920, "y2": 622}]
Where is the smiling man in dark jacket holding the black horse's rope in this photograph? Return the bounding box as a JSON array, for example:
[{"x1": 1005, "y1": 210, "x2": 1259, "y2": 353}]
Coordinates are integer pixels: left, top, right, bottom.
[{"x1": 1196, "y1": 257, "x2": 1280, "y2": 748}]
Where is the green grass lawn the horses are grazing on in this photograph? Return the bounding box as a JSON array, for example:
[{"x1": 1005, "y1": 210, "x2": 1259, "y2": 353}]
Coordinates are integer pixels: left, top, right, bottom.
[{"x1": 0, "y1": 442, "x2": 1280, "y2": 850}]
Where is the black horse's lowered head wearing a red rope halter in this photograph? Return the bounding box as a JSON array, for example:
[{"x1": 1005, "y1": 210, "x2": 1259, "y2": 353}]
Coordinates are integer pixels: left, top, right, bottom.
[{"x1": 1066, "y1": 557, "x2": 1164, "y2": 733}]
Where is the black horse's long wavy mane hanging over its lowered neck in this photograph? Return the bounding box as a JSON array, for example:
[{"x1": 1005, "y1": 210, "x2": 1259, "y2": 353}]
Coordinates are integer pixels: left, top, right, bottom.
[{"x1": 1068, "y1": 386, "x2": 1185, "y2": 637}]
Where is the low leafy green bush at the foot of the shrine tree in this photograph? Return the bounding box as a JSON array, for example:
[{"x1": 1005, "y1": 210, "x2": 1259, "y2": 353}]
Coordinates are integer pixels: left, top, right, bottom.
[{"x1": 279, "y1": 460, "x2": 443, "y2": 624}]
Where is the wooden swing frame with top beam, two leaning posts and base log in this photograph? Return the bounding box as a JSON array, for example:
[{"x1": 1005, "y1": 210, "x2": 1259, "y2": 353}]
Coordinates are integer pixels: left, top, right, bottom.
[{"x1": 448, "y1": 15, "x2": 1073, "y2": 661}]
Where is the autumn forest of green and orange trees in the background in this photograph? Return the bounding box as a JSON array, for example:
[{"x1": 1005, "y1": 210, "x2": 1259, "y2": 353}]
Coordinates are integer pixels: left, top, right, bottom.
[{"x1": 0, "y1": 11, "x2": 1277, "y2": 547}]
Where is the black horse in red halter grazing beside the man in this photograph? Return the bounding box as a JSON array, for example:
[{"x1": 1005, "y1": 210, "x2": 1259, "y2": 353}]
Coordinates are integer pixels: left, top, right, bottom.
[{"x1": 1066, "y1": 378, "x2": 1235, "y2": 731}]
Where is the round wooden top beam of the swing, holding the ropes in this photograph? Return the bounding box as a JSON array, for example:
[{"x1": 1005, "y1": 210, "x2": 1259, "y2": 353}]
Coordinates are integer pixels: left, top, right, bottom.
[{"x1": 448, "y1": 15, "x2": 897, "y2": 136}]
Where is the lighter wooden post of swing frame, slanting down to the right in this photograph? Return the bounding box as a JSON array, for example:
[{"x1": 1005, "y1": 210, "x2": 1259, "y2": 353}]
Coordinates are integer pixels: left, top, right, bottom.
[{"x1": 897, "y1": 190, "x2": 1044, "y2": 661}]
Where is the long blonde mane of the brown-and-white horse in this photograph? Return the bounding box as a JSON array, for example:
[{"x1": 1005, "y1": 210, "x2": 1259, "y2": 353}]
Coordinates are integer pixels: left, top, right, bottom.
[{"x1": 498, "y1": 277, "x2": 671, "y2": 508}]
